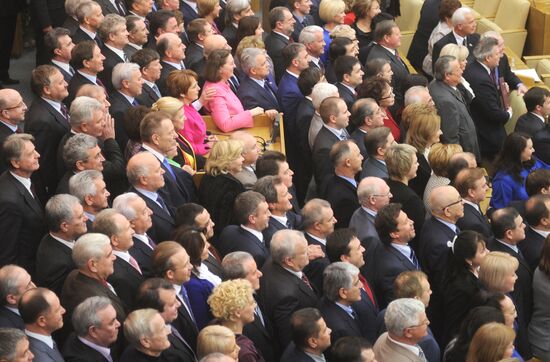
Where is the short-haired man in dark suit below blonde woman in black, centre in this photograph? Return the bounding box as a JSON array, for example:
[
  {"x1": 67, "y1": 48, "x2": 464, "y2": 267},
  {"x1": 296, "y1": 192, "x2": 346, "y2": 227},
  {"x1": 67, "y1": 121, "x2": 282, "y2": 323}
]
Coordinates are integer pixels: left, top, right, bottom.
[{"x1": 216, "y1": 191, "x2": 270, "y2": 268}]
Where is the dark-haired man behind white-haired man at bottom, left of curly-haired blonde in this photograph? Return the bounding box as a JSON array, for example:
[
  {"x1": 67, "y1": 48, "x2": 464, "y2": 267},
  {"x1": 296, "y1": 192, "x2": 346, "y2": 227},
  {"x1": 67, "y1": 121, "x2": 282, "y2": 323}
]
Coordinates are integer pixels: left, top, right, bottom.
[{"x1": 136, "y1": 278, "x2": 197, "y2": 362}]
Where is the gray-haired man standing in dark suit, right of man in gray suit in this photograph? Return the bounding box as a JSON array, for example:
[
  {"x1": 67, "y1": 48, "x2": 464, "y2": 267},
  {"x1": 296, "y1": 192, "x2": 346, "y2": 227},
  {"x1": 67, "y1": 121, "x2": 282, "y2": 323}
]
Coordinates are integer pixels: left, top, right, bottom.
[{"x1": 463, "y1": 38, "x2": 512, "y2": 161}]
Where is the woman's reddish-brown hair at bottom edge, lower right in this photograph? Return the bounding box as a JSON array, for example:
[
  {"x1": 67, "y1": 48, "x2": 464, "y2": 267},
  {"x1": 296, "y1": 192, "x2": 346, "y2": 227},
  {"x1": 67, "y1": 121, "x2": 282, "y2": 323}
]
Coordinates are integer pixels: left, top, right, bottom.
[{"x1": 466, "y1": 322, "x2": 516, "y2": 362}]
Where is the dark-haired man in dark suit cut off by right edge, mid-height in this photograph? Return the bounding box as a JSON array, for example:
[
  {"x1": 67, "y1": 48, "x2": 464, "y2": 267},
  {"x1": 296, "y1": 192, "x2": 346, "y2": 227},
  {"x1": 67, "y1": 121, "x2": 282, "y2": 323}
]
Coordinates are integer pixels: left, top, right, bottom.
[{"x1": 519, "y1": 195, "x2": 550, "y2": 270}]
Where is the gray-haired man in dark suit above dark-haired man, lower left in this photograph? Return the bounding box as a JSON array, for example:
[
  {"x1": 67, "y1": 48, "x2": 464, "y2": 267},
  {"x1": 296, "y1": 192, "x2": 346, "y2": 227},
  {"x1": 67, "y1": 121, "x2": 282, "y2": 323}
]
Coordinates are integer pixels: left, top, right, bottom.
[{"x1": 36, "y1": 194, "x2": 87, "y2": 295}]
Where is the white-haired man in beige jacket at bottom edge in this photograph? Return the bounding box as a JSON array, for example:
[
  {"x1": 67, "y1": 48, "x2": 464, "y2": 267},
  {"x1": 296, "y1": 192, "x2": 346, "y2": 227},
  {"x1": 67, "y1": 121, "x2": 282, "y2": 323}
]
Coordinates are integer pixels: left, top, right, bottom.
[{"x1": 373, "y1": 298, "x2": 430, "y2": 362}]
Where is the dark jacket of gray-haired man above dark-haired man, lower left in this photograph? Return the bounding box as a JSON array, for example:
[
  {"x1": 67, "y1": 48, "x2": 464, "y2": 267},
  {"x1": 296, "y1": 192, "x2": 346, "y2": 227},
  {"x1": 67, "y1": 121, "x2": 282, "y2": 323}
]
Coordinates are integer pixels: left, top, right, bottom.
[{"x1": 36, "y1": 234, "x2": 76, "y2": 295}]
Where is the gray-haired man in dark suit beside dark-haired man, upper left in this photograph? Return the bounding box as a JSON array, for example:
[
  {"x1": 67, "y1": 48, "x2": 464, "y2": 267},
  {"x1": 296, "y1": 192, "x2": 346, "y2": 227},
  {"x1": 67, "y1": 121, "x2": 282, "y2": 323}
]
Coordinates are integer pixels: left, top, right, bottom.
[{"x1": 97, "y1": 14, "x2": 128, "y2": 93}]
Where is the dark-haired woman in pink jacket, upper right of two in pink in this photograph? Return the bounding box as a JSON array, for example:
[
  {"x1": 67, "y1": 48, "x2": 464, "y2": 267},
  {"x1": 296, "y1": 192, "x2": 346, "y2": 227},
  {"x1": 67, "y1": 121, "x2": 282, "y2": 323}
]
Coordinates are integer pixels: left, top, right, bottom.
[{"x1": 203, "y1": 49, "x2": 264, "y2": 132}]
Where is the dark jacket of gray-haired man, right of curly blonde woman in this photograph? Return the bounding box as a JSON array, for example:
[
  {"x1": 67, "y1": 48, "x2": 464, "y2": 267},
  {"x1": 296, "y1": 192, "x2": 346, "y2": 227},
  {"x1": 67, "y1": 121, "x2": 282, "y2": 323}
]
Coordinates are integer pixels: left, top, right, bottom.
[{"x1": 260, "y1": 260, "x2": 319, "y2": 350}]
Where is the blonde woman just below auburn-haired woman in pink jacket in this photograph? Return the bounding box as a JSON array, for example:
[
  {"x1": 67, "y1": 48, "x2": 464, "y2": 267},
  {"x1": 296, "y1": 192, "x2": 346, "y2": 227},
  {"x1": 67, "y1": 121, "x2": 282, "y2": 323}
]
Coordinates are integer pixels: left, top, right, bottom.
[{"x1": 151, "y1": 97, "x2": 204, "y2": 175}]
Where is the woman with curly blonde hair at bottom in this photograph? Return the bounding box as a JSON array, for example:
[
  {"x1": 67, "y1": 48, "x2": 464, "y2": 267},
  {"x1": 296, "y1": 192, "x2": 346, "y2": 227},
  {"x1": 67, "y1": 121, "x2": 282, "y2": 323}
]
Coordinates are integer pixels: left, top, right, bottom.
[{"x1": 208, "y1": 279, "x2": 265, "y2": 362}]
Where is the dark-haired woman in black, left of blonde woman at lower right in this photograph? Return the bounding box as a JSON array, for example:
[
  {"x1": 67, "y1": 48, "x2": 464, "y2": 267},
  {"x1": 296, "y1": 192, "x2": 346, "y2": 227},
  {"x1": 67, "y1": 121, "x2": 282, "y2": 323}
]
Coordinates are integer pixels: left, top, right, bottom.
[{"x1": 441, "y1": 230, "x2": 489, "y2": 345}]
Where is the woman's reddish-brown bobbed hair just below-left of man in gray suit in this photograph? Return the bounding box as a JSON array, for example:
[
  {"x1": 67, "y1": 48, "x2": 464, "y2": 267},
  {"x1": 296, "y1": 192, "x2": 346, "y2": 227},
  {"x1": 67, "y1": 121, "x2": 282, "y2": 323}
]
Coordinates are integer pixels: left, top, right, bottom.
[{"x1": 401, "y1": 103, "x2": 441, "y2": 153}]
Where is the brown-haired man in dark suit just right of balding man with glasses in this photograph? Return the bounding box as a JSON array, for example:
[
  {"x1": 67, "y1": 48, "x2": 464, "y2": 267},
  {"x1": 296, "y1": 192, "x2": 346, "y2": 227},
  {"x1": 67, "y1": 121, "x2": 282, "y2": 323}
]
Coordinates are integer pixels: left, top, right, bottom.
[{"x1": 454, "y1": 168, "x2": 493, "y2": 240}]
